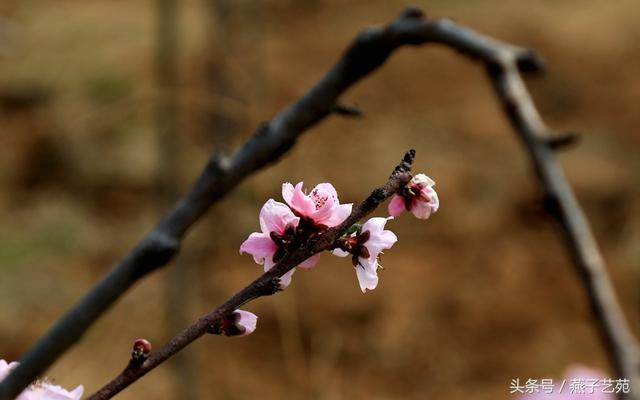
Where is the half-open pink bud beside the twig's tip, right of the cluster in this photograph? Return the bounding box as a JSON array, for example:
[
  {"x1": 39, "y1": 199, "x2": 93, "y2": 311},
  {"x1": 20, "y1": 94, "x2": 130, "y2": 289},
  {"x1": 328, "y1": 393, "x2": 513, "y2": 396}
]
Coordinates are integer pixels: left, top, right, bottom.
[{"x1": 388, "y1": 174, "x2": 440, "y2": 219}]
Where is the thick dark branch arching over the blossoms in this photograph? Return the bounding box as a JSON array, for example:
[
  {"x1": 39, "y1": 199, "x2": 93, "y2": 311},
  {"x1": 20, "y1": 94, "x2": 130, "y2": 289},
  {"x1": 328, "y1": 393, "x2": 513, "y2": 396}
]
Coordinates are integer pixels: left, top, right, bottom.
[{"x1": 0, "y1": 8, "x2": 640, "y2": 400}]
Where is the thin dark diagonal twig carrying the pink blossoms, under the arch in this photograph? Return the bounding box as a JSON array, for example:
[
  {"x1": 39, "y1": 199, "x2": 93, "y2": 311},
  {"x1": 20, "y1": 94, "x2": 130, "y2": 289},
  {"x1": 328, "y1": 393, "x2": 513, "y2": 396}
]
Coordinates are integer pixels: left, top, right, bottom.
[{"x1": 87, "y1": 150, "x2": 415, "y2": 400}]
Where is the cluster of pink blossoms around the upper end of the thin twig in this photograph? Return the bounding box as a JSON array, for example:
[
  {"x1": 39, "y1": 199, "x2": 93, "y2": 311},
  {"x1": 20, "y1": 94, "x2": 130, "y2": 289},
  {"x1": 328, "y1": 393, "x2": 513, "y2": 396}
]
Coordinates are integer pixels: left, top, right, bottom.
[{"x1": 240, "y1": 174, "x2": 439, "y2": 293}]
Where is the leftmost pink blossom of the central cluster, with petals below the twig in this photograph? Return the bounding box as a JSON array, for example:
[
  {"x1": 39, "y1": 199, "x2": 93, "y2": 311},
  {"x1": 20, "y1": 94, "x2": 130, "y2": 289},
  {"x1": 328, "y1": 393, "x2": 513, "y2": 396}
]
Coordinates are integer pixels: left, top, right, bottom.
[{"x1": 240, "y1": 199, "x2": 320, "y2": 289}]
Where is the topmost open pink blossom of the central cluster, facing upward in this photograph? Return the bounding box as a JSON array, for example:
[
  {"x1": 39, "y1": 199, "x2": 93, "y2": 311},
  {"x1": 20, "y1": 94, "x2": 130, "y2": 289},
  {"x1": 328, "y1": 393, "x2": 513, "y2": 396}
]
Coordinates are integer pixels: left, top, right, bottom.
[{"x1": 282, "y1": 182, "x2": 353, "y2": 227}]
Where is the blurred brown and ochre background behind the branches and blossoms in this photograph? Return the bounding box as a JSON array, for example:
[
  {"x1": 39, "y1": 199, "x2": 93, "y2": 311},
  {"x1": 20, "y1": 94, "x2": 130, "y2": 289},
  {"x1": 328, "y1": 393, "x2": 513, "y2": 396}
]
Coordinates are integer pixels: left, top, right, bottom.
[{"x1": 0, "y1": 0, "x2": 640, "y2": 399}]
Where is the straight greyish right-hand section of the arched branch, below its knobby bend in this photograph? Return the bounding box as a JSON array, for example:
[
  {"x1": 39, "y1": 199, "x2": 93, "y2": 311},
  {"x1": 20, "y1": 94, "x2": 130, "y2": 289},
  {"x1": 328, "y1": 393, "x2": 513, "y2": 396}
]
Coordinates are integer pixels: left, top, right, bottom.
[{"x1": 487, "y1": 52, "x2": 640, "y2": 400}]
